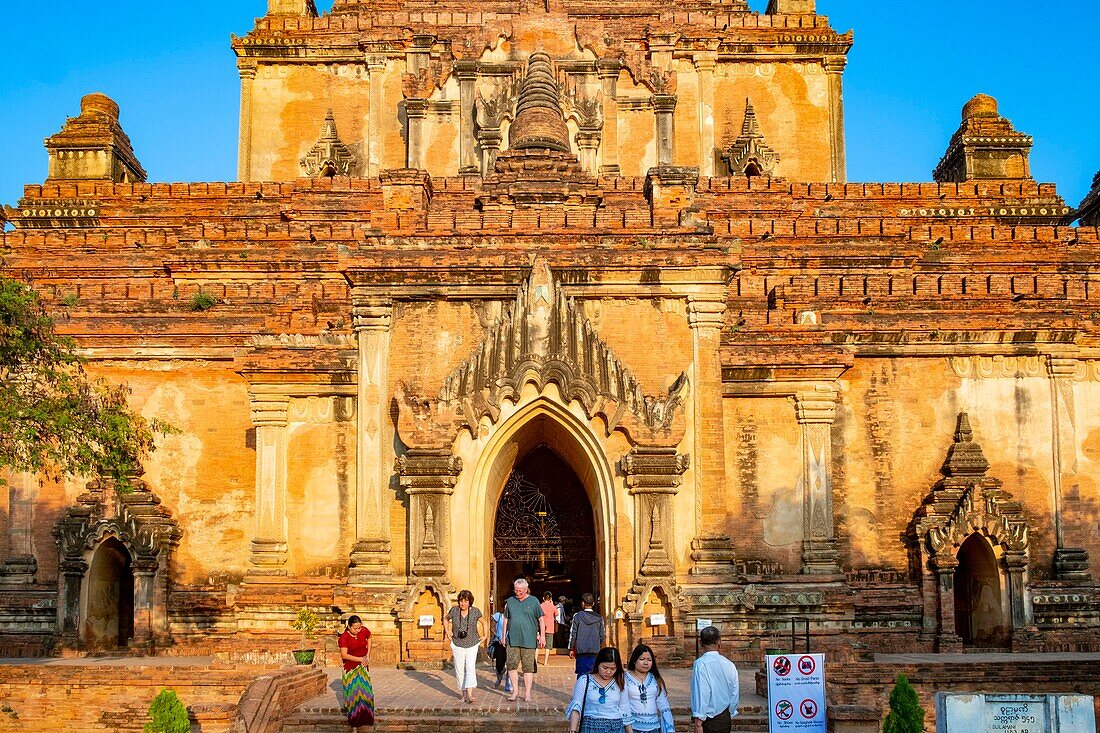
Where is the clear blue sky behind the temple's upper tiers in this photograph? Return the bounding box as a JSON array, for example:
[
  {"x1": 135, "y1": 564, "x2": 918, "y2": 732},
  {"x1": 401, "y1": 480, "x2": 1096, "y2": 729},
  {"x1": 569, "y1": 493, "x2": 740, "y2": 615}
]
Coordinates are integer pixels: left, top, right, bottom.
[{"x1": 0, "y1": 0, "x2": 1100, "y2": 206}]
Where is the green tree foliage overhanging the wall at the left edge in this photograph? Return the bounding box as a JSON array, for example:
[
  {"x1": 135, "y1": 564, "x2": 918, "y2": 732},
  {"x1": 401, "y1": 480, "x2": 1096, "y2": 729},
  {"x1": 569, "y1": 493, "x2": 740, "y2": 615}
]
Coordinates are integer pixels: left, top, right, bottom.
[{"x1": 0, "y1": 277, "x2": 173, "y2": 490}]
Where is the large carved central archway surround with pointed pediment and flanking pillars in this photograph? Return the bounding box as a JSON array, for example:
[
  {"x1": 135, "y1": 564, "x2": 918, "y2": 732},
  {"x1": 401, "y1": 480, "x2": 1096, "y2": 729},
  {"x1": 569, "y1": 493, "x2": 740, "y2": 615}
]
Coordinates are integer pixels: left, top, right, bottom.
[{"x1": 395, "y1": 260, "x2": 688, "y2": 651}]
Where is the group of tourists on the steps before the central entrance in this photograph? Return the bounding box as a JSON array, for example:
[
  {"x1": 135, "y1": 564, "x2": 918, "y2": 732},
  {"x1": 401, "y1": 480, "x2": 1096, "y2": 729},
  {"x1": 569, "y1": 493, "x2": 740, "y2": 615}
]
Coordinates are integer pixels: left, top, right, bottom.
[{"x1": 339, "y1": 578, "x2": 739, "y2": 733}]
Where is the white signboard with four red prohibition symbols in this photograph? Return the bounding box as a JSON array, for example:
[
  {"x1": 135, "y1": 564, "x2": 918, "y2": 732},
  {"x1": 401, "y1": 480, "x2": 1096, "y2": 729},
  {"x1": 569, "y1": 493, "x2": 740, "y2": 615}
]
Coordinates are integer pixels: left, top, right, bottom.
[{"x1": 768, "y1": 654, "x2": 825, "y2": 733}]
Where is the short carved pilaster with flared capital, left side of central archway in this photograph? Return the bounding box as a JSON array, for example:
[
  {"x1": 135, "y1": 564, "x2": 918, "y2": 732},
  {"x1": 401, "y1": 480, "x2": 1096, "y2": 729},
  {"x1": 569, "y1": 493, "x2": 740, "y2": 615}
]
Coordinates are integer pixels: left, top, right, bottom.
[{"x1": 396, "y1": 448, "x2": 462, "y2": 584}]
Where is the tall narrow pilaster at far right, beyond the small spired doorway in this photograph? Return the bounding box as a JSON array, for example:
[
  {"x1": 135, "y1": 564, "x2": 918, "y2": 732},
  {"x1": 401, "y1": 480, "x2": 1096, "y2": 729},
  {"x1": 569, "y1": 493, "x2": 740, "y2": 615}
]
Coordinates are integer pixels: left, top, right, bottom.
[{"x1": 1047, "y1": 357, "x2": 1090, "y2": 582}]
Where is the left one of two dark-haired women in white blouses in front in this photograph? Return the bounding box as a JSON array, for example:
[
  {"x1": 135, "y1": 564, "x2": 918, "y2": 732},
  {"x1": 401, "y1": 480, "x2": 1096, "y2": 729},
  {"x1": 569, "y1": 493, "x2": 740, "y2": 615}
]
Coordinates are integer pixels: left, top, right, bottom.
[{"x1": 565, "y1": 646, "x2": 634, "y2": 733}]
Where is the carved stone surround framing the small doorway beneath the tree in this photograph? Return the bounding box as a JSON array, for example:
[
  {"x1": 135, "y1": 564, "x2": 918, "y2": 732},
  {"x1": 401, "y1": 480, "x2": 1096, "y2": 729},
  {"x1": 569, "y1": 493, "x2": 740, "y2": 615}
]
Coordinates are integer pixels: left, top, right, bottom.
[{"x1": 53, "y1": 468, "x2": 183, "y2": 647}]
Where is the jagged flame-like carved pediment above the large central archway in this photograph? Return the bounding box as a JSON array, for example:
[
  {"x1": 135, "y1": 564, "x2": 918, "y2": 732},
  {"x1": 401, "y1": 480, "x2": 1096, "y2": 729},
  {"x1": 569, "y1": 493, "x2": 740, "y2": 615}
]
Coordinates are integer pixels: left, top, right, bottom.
[{"x1": 397, "y1": 260, "x2": 688, "y2": 447}]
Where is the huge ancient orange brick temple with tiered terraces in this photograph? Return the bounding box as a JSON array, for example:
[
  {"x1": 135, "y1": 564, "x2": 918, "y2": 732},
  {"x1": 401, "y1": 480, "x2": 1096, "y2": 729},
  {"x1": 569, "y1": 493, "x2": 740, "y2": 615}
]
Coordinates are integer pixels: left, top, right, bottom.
[{"x1": 0, "y1": 0, "x2": 1100, "y2": 660}]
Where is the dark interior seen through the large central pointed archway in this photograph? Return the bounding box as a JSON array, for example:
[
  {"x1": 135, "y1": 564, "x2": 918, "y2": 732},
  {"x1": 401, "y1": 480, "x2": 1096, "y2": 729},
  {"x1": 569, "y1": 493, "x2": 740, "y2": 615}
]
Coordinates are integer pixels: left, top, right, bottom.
[{"x1": 492, "y1": 444, "x2": 600, "y2": 645}]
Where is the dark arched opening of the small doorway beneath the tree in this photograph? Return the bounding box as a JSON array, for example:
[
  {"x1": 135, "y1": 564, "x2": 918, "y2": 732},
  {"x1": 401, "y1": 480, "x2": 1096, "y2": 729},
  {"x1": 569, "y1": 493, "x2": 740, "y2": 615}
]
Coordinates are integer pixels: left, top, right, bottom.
[{"x1": 84, "y1": 537, "x2": 134, "y2": 648}]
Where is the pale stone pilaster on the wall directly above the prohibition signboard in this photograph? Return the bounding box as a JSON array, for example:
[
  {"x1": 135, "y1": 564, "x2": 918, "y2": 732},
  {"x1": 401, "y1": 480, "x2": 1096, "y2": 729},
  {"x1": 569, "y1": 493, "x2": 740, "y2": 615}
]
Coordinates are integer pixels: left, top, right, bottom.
[{"x1": 794, "y1": 385, "x2": 840, "y2": 575}]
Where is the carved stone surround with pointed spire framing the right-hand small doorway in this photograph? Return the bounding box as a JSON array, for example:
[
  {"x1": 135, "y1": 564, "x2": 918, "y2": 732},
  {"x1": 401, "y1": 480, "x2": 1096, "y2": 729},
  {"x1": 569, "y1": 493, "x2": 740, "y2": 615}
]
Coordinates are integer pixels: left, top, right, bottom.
[{"x1": 906, "y1": 413, "x2": 1033, "y2": 650}]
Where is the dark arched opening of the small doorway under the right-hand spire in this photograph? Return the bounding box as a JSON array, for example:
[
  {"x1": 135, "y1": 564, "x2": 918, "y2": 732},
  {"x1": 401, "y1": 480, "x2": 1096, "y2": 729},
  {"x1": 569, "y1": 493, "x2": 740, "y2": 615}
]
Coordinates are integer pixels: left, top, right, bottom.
[{"x1": 955, "y1": 533, "x2": 1009, "y2": 647}]
